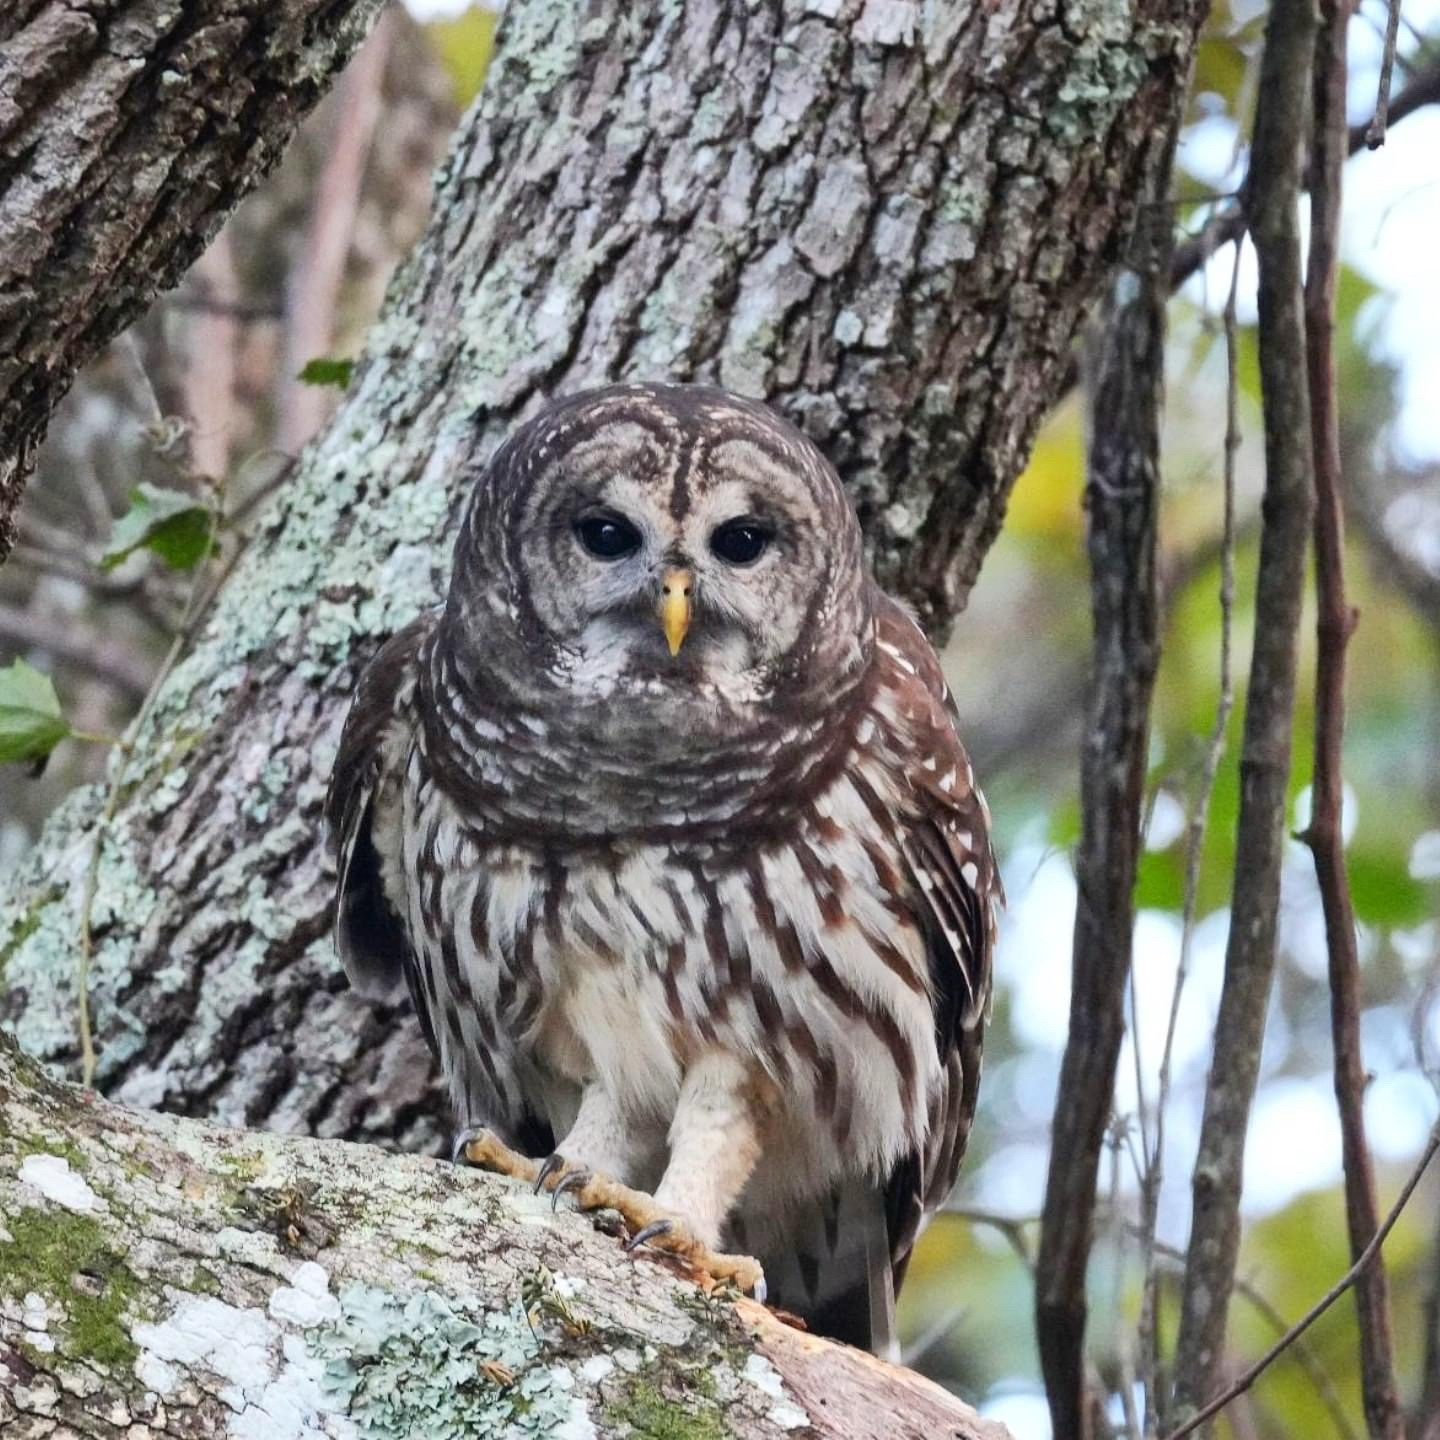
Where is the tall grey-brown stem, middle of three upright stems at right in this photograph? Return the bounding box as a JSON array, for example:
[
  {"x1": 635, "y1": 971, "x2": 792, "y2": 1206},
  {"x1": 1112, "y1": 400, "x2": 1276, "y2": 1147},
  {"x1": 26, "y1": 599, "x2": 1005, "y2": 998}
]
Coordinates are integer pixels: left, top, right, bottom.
[{"x1": 1174, "y1": 0, "x2": 1316, "y2": 1421}]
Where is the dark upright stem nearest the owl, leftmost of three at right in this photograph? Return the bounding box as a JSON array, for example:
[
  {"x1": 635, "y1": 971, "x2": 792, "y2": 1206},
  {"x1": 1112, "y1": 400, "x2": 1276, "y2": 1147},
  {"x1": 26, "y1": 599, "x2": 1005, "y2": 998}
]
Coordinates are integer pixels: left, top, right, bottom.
[{"x1": 1035, "y1": 126, "x2": 1174, "y2": 1440}]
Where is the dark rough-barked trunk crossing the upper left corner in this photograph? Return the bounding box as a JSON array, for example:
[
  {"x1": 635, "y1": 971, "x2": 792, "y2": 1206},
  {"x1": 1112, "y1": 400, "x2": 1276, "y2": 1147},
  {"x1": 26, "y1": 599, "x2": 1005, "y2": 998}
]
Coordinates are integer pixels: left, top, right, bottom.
[{"x1": 0, "y1": 0, "x2": 382, "y2": 562}]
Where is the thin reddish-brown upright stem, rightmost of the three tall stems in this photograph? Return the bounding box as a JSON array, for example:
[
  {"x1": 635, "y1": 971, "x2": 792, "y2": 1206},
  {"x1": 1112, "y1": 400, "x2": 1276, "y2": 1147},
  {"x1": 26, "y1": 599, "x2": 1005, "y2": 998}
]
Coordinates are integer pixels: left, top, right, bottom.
[{"x1": 1300, "y1": 0, "x2": 1404, "y2": 1440}]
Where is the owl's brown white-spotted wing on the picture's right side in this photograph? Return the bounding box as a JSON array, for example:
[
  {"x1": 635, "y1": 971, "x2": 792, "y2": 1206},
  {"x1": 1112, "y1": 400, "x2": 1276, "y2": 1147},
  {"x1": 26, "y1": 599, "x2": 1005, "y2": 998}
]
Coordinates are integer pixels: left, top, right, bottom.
[{"x1": 878, "y1": 602, "x2": 1004, "y2": 1292}]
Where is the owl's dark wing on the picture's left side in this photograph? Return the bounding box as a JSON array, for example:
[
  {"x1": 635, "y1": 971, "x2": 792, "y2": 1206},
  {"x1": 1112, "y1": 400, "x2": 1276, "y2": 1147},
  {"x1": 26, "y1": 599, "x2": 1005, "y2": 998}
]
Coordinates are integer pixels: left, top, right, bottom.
[{"x1": 325, "y1": 615, "x2": 435, "y2": 1050}]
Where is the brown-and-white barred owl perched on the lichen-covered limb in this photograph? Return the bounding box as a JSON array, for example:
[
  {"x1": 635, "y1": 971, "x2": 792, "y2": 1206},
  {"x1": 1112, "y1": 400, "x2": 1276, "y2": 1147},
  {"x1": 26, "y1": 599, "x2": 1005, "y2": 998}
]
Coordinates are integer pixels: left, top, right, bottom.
[{"x1": 327, "y1": 384, "x2": 1001, "y2": 1348}]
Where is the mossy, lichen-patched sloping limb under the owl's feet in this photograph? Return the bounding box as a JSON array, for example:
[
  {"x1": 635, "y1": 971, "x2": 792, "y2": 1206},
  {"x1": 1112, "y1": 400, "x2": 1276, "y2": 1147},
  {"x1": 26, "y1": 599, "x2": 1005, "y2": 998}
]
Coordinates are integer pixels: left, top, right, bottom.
[{"x1": 0, "y1": 1038, "x2": 1007, "y2": 1440}]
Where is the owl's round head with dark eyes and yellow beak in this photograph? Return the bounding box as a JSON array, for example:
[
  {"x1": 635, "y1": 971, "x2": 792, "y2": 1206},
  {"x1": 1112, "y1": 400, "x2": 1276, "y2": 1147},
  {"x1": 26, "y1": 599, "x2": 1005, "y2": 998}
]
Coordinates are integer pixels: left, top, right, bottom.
[{"x1": 445, "y1": 384, "x2": 870, "y2": 725}]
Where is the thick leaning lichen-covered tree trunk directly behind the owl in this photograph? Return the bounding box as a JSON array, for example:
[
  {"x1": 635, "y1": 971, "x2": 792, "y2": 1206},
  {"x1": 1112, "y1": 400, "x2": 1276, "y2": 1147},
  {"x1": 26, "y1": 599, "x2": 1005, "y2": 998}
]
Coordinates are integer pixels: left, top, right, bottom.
[{"x1": 0, "y1": 0, "x2": 1204, "y2": 1175}]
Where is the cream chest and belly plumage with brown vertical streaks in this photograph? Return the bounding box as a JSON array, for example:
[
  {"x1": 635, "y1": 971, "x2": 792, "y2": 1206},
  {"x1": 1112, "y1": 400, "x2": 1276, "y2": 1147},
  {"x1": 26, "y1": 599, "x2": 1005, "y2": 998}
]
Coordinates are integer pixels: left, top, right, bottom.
[{"x1": 402, "y1": 648, "x2": 940, "y2": 1211}]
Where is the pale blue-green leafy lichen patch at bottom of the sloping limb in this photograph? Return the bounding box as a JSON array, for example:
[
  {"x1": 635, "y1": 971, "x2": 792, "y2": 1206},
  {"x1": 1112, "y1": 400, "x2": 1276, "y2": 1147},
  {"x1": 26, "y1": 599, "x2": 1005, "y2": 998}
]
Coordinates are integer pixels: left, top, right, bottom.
[{"x1": 305, "y1": 1284, "x2": 590, "y2": 1440}]
